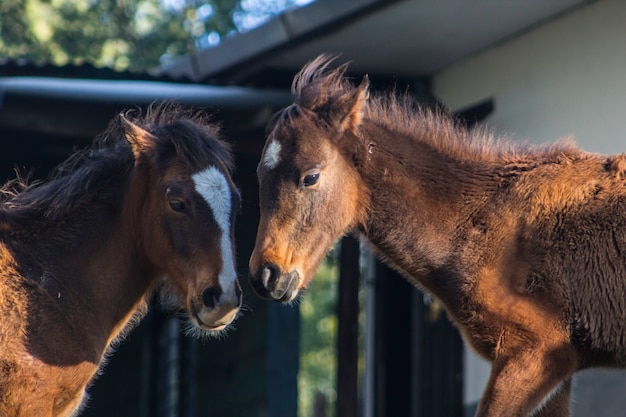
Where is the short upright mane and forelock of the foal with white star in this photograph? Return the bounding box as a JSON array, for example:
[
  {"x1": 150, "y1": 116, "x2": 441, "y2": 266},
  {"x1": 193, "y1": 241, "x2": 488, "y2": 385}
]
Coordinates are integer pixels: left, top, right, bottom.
[{"x1": 286, "y1": 55, "x2": 581, "y2": 162}]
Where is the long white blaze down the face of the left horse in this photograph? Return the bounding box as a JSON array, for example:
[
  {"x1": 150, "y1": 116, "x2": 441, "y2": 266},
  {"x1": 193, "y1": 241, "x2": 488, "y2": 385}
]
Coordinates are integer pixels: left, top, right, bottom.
[{"x1": 192, "y1": 167, "x2": 237, "y2": 293}]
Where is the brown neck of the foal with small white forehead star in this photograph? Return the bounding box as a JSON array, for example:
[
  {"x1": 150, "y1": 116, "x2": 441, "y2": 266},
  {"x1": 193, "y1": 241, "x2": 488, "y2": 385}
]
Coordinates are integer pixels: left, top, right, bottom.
[{"x1": 362, "y1": 123, "x2": 497, "y2": 287}]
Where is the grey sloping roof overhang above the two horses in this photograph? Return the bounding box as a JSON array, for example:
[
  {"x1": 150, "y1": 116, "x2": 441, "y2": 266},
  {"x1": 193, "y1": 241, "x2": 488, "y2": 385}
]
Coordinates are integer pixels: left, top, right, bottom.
[{"x1": 163, "y1": 0, "x2": 591, "y2": 83}]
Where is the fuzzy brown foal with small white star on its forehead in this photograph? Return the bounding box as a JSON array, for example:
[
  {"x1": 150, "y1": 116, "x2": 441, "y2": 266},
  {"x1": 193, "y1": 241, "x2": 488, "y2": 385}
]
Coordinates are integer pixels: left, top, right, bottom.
[{"x1": 250, "y1": 57, "x2": 626, "y2": 417}]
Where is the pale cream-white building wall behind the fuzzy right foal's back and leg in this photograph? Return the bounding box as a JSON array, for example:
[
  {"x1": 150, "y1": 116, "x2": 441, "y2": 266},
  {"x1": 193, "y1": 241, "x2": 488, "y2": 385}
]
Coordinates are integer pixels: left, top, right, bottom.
[{"x1": 433, "y1": 0, "x2": 626, "y2": 410}]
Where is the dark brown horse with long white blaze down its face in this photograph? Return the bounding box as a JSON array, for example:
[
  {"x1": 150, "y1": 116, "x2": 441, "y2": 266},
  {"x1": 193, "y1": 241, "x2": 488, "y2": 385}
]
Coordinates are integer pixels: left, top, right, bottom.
[{"x1": 0, "y1": 105, "x2": 241, "y2": 417}]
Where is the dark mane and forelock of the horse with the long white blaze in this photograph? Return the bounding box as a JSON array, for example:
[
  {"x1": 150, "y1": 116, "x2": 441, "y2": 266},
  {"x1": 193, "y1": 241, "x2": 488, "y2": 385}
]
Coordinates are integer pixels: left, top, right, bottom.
[{"x1": 0, "y1": 103, "x2": 233, "y2": 221}]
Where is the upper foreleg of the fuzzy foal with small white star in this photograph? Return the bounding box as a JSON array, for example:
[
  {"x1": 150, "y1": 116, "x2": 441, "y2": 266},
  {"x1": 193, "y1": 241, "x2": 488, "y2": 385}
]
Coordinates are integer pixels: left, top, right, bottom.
[{"x1": 476, "y1": 345, "x2": 576, "y2": 417}]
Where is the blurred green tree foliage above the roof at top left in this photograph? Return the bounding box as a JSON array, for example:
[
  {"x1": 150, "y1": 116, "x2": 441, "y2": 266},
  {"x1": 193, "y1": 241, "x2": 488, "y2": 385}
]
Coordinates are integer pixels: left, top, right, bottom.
[{"x1": 0, "y1": 0, "x2": 306, "y2": 72}]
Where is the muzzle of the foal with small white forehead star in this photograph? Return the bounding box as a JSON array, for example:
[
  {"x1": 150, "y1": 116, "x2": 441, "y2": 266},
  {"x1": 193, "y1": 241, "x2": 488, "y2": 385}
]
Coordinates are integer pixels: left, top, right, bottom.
[{"x1": 250, "y1": 263, "x2": 298, "y2": 302}]
